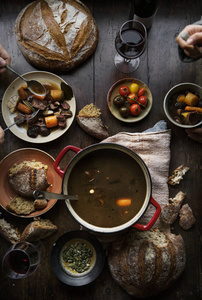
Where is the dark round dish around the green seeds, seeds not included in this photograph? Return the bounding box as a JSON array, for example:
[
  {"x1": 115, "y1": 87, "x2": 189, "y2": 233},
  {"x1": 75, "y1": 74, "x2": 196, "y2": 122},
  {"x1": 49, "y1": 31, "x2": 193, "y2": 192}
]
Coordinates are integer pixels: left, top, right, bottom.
[{"x1": 51, "y1": 230, "x2": 105, "y2": 286}]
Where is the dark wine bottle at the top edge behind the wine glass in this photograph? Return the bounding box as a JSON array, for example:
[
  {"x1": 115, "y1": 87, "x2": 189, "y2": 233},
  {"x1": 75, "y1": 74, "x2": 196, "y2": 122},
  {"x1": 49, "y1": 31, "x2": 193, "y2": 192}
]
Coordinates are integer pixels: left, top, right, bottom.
[{"x1": 130, "y1": 0, "x2": 157, "y2": 29}]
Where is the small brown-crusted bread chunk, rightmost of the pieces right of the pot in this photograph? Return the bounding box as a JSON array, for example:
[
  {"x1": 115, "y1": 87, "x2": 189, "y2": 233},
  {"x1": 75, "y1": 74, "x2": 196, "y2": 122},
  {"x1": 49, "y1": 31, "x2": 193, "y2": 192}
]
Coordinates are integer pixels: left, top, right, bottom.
[{"x1": 179, "y1": 204, "x2": 196, "y2": 230}]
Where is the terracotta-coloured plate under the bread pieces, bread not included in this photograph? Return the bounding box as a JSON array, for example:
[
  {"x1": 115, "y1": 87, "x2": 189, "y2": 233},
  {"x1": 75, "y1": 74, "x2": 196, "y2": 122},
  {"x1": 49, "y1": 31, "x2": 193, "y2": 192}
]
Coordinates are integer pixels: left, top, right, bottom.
[{"x1": 0, "y1": 148, "x2": 62, "y2": 218}]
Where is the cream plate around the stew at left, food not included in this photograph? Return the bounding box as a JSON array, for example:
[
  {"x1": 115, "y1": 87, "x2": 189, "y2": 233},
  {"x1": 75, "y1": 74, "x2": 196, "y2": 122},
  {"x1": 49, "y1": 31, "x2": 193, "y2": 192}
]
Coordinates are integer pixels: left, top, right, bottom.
[{"x1": 2, "y1": 71, "x2": 76, "y2": 144}]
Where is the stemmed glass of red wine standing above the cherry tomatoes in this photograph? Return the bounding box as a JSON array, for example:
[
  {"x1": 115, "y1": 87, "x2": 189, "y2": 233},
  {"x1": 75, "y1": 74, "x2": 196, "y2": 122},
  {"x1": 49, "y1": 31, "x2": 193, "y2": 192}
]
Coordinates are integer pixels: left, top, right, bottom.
[{"x1": 114, "y1": 20, "x2": 147, "y2": 73}]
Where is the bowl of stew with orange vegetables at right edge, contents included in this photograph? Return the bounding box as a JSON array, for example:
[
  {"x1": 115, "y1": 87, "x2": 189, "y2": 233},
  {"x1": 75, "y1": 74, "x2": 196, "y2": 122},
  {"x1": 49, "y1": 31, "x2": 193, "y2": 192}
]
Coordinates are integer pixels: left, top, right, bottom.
[{"x1": 163, "y1": 82, "x2": 202, "y2": 128}]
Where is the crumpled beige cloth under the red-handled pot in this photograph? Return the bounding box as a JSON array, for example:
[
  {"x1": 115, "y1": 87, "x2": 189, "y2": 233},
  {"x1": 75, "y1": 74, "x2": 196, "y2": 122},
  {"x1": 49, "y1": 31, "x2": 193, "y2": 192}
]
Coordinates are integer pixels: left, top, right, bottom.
[{"x1": 102, "y1": 130, "x2": 171, "y2": 229}]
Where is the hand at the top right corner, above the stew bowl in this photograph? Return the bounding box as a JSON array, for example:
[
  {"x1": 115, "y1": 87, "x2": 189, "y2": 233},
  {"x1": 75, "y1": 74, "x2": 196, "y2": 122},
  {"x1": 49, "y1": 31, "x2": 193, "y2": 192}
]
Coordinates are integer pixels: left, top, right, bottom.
[{"x1": 176, "y1": 25, "x2": 202, "y2": 58}]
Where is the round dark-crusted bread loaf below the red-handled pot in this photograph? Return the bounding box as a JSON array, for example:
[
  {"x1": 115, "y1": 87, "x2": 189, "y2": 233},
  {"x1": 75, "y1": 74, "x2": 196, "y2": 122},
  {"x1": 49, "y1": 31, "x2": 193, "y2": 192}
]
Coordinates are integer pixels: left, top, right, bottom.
[{"x1": 108, "y1": 229, "x2": 186, "y2": 298}]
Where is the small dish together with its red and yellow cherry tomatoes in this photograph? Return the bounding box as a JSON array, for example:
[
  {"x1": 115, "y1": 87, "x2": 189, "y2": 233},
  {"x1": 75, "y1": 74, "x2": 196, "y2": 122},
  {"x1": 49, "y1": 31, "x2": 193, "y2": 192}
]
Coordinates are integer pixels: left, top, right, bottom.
[{"x1": 107, "y1": 78, "x2": 153, "y2": 123}]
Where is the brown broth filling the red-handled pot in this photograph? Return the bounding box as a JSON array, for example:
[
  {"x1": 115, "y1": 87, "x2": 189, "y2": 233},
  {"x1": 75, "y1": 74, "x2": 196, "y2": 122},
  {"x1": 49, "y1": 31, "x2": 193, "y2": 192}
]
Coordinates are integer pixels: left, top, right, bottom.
[{"x1": 68, "y1": 149, "x2": 146, "y2": 228}]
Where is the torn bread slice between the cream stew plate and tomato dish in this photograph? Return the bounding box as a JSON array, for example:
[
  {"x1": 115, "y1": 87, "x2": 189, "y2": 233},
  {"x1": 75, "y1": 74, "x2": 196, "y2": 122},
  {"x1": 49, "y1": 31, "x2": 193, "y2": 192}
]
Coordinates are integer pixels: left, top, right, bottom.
[{"x1": 76, "y1": 103, "x2": 109, "y2": 140}]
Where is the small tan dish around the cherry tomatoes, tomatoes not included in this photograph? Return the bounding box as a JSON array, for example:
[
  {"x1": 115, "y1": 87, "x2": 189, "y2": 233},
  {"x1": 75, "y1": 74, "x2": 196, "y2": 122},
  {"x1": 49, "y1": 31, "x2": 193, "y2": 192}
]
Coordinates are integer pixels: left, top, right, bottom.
[{"x1": 107, "y1": 78, "x2": 153, "y2": 123}]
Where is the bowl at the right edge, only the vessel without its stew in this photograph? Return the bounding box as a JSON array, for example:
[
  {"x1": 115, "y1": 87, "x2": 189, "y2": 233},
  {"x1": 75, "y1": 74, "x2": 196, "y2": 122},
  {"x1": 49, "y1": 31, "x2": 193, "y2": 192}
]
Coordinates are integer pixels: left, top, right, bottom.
[{"x1": 163, "y1": 82, "x2": 202, "y2": 128}]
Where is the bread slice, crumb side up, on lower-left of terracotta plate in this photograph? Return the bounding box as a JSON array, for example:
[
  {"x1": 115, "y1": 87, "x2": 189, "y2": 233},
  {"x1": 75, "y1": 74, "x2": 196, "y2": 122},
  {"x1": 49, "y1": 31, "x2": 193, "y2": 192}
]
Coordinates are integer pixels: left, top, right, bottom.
[{"x1": 6, "y1": 195, "x2": 35, "y2": 215}]
